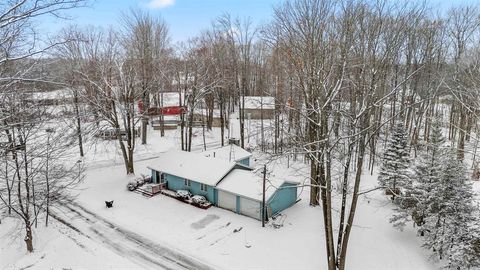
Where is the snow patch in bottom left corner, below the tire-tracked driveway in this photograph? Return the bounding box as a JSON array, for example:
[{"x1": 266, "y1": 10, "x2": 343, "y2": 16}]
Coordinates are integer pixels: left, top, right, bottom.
[{"x1": 0, "y1": 218, "x2": 142, "y2": 270}]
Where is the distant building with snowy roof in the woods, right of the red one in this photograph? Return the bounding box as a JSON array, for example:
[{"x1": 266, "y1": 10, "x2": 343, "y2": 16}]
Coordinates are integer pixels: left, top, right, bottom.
[{"x1": 240, "y1": 96, "x2": 275, "y2": 119}]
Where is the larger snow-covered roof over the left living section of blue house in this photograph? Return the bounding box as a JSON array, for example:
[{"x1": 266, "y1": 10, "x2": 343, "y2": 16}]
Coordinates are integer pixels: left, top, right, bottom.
[{"x1": 147, "y1": 150, "x2": 235, "y2": 186}]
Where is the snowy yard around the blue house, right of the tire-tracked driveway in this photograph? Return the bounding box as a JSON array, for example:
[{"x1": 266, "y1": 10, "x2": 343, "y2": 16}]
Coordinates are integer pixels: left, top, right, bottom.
[{"x1": 69, "y1": 156, "x2": 436, "y2": 270}]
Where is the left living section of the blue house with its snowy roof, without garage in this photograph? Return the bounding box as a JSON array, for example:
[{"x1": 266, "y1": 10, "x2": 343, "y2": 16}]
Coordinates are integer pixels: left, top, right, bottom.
[{"x1": 147, "y1": 150, "x2": 248, "y2": 203}]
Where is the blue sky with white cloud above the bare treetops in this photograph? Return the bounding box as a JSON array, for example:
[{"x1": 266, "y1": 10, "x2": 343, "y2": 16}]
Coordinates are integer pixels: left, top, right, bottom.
[{"x1": 40, "y1": 0, "x2": 480, "y2": 42}]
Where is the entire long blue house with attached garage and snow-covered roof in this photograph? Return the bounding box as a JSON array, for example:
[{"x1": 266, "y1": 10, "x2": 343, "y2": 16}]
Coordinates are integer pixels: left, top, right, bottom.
[{"x1": 148, "y1": 150, "x2": 298, "y2": 220}]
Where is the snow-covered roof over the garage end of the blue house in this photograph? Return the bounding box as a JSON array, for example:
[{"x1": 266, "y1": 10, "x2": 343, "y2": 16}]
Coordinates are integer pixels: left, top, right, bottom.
[{"x1": 217, "y1": 169, "x2": 297, "y2": 201}]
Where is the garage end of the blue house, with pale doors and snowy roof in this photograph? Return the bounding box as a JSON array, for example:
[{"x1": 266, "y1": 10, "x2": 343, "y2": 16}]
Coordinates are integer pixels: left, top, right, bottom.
[{"x1": 215, "y1": 169, "x2": 298, "y2": 220}]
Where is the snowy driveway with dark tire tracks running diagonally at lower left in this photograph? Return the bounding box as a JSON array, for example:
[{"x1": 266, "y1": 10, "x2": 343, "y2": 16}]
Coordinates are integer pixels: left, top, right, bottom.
[{"x1": 53, "y1": 201, "x2": 214, "y2": 270}]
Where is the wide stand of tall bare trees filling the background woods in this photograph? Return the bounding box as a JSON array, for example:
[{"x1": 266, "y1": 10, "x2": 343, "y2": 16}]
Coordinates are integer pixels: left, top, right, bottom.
[{"x1": 0, "y1": 0, "x2": 480, "y2": 270}]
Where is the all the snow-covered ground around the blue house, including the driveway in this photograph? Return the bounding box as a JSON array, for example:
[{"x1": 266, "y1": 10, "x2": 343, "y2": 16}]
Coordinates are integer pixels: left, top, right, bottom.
[{"x1": 0, "y1": 125, "x2": 439, "y2": 269}]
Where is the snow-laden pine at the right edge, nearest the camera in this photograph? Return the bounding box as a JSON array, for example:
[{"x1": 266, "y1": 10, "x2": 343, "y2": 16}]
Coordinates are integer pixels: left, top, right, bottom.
[{"x1": 422, "y1": 150, "x2": 479, "y2": 269}]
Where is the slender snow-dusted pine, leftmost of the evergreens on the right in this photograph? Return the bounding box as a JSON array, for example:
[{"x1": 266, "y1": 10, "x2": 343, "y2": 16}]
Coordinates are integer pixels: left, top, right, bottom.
[{"x1": 378, "y1": 121, "x2": 410, "y2": 200}]
